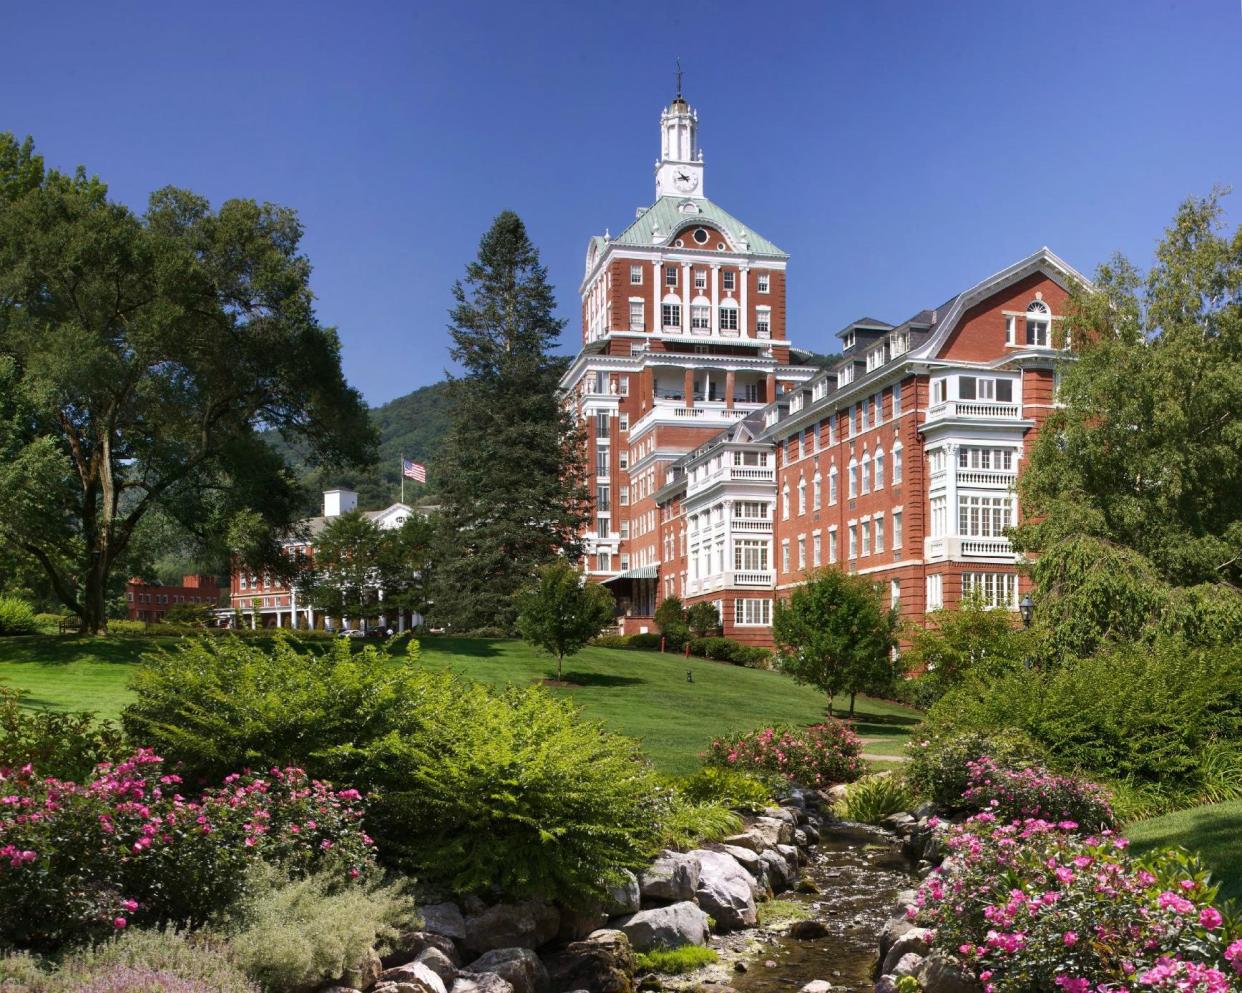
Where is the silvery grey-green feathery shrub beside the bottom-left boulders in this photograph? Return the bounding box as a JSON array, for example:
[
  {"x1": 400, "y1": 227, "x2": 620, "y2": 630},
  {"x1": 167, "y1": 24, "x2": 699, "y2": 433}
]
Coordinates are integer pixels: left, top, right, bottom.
[{"x1": 229, "y1": 866, "x2": 415, "y2": 991}]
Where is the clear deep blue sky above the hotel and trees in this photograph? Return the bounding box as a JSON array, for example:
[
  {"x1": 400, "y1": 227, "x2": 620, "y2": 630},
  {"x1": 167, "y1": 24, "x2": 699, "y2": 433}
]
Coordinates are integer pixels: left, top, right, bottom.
[{"x1": 0, "y1": 0, "x2": 1242, "y2": 403}]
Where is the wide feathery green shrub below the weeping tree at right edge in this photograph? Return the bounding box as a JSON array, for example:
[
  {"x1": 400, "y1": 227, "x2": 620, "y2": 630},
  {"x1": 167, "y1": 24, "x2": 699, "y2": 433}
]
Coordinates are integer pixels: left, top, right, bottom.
[{"x1": 925, "y1": 640, "x2": 1242, "y2": 804}]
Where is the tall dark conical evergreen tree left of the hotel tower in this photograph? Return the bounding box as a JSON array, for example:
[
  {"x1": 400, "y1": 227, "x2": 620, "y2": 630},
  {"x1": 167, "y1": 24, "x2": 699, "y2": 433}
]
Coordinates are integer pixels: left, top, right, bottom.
[{"x1": 431, "y1": 211, "x2": 590, "y2": 631}]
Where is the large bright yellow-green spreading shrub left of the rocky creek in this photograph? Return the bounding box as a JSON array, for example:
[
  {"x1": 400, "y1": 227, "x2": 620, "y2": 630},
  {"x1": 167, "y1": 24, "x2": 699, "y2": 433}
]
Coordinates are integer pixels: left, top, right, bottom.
[{"x1": 124, "y1": 638, "x2": 661, "y2": 900}]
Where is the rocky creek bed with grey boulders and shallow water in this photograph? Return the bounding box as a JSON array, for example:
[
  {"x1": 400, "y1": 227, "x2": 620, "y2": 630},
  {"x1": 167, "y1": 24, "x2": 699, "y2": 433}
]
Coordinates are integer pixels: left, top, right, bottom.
[{"x1": 320, "y1": 791, "x2": 938, "y2": 993}]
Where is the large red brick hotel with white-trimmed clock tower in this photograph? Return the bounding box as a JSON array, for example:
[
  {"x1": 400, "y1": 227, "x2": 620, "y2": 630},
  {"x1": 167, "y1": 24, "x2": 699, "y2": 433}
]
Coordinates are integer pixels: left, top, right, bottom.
[{"x1": 563, "y1": 97, "x2": 1083, "y2": 644}]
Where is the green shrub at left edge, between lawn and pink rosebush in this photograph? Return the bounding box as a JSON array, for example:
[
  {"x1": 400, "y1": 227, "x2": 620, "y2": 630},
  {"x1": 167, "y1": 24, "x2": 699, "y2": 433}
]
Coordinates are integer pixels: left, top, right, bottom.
[{"x1": 0, "y1": 686, "x2": 127, "y2": 780}]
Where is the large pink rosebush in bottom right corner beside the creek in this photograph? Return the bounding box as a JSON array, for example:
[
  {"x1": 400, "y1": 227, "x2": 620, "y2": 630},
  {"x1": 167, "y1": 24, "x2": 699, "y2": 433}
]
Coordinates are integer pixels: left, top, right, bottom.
[{"x1": 910, "y1": 813, "x2": 1242, "y2": 993}]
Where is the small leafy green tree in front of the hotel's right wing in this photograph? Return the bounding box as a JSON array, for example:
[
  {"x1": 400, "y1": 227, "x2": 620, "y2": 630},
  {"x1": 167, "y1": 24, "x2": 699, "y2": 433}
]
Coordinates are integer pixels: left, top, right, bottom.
[{"x1": 773, "y1": 568, "x2": 898, "y2": 716}]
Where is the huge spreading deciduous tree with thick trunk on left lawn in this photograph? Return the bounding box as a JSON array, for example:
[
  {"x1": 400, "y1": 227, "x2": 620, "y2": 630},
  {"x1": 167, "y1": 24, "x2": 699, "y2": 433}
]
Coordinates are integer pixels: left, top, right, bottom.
[{"x1": 0, "y1": 135, "x2": 374, "y2": 631}]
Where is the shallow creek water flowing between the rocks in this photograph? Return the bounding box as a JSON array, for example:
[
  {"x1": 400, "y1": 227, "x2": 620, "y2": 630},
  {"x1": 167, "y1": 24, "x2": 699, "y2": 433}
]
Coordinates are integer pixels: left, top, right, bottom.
[{"x1": 727, "y1": 824, "x2": 917, "y2": 993}]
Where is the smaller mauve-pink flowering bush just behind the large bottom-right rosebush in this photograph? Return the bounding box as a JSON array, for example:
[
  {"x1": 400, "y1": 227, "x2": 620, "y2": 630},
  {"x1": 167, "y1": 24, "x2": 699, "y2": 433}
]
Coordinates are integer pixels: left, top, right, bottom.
[{"x1": 961, "y1": 755, "x2": 1117, "y2": 830}]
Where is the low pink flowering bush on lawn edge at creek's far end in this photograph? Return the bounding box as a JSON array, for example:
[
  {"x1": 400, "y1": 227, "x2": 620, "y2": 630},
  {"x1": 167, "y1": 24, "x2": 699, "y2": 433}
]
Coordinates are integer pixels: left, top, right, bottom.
[{"x1": 704, "y1": 720, "x2": 863, "y2": 786}]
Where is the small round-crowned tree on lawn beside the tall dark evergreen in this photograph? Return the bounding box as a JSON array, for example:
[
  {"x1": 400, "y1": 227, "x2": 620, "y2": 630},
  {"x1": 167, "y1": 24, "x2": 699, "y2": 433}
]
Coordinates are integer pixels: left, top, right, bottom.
[{"x1": 517, "y1": 559, "x2": 616, "y2": 681}]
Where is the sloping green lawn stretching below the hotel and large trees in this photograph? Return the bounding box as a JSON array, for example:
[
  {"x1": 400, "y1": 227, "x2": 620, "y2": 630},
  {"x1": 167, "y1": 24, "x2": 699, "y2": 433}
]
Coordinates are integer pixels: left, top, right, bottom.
[{"x1": 0, "y1": 637, "x2": 919, "y2": 773}]
